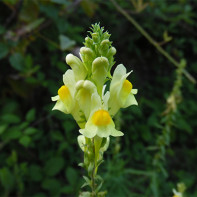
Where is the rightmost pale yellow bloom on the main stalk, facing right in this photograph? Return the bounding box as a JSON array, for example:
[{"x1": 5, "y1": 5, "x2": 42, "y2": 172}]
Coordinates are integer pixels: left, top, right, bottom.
[{"x1": 109, "y1": 64, "x2": 138, "y2": 116}]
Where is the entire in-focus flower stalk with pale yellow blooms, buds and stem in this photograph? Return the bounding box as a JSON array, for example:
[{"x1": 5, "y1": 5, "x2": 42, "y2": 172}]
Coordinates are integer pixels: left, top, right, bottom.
[{"x1": 52, "y1": 24, "x2": 137, "y2": 197}]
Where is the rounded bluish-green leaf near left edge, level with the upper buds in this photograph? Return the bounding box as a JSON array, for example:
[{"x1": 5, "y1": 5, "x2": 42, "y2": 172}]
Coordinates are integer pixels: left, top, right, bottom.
[{"x1": 9, "y1": 53, "x2": 25, "y2": 71}]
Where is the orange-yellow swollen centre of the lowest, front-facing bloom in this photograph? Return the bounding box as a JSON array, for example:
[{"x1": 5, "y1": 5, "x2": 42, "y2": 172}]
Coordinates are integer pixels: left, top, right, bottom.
[{"x1": 92, "y1": 110, "x2": 111, "y2": 126}]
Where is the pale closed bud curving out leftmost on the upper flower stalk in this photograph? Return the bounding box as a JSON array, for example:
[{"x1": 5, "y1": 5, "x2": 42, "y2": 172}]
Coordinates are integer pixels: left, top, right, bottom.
[{"x1": 66, "y1": 53, "x2": 87, "y2": 81}]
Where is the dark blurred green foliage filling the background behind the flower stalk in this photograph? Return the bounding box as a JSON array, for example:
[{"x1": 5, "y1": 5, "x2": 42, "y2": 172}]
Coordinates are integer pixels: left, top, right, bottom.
[{"x1": 0, "y1": 0, "x2": 197, "y2": 197}]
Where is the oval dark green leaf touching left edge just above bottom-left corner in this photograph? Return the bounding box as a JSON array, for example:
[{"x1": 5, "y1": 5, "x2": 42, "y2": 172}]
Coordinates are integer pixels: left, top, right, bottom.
[{"x1": 0, "y1": 167, "x2": 14, "y2": 191}]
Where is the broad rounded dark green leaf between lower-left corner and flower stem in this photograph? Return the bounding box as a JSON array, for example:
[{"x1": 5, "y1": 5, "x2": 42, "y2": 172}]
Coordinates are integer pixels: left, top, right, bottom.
[{"x1": 44, "y1": 157, "x2": 64, "y2": 176}]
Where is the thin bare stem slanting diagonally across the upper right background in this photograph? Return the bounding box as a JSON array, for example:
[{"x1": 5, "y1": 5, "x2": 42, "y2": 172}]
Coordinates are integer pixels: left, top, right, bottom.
[{"x1": 110, "y1": 0, "x2": 196, "y2": 84}]
